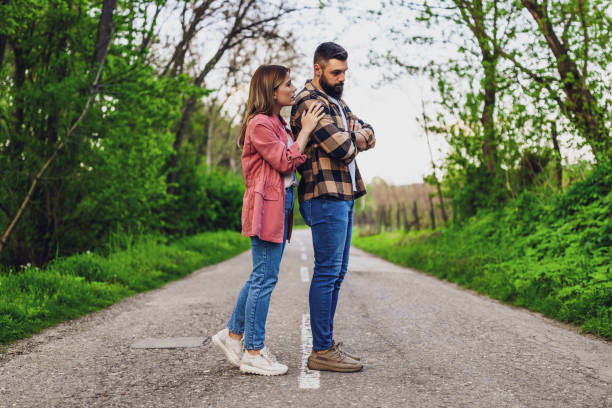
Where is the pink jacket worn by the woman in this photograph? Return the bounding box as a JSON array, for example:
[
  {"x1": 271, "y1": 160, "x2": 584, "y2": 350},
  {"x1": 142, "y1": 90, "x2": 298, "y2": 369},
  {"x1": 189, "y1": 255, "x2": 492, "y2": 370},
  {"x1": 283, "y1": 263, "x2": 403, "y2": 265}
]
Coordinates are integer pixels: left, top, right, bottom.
[{"x1": 242, "y1": 114, "x2": 306, "y2": 243}]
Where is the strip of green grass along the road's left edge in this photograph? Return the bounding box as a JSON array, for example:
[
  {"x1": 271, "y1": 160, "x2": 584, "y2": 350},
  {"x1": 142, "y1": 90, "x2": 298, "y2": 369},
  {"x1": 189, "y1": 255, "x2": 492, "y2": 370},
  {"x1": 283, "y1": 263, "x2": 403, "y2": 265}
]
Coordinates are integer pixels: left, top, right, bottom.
[{"x1": 0, "y1": 231, "x2": 250, "y2": 344}]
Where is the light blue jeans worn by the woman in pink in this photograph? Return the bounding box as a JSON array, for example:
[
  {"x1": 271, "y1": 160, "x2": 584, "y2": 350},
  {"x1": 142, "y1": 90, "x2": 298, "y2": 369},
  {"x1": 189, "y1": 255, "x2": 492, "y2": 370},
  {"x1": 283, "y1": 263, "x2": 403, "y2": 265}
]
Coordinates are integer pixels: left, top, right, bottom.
[{"x1": 227, "y1": 188, "x2": 294, "y2": 350}]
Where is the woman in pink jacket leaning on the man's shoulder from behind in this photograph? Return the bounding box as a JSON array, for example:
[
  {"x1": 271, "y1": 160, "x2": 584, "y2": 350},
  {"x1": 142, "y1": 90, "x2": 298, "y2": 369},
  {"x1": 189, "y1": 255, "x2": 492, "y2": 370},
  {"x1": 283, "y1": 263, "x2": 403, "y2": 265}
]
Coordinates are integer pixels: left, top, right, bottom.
[{"x1": 212, "y1": 65, "x2": 323, "y2": 375}]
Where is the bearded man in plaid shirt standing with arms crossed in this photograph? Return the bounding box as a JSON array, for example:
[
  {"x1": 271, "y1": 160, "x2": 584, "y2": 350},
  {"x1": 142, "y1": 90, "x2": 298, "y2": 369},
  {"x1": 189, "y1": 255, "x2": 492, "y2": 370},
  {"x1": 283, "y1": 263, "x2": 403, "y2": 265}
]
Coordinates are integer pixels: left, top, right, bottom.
[{"x1": 291, "y1": 42, "x2": 376, "y2": 372}]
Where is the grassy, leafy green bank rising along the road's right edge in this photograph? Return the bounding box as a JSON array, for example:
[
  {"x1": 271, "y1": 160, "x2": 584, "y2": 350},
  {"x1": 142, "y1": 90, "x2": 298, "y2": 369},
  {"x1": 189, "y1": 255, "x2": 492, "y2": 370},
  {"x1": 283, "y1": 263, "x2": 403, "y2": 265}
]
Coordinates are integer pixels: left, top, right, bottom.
[{"x1": 354, "y1": 163, "x2": 612, "y2": 339}]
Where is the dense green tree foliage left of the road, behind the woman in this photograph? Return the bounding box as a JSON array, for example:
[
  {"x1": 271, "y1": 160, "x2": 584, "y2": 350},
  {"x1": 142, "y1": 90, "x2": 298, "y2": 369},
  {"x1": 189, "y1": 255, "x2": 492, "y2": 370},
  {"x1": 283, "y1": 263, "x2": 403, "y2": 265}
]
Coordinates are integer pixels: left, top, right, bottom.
[{"x1": 0, "y1": 0, "x2": 244, "y2": 266}]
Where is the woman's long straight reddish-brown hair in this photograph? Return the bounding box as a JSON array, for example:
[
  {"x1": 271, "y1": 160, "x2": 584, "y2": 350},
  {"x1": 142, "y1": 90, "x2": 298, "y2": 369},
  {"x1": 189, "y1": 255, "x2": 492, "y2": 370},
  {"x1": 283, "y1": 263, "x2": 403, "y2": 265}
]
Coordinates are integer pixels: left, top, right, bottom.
[{"x1": 238, "y1": 65, "x2": 289, "y2": 149}]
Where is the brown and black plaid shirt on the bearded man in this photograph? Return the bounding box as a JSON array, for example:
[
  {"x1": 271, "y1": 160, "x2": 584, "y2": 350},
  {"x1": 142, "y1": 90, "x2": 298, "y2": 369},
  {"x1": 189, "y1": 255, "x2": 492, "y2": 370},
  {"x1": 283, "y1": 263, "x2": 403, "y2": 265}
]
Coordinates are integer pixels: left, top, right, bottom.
[{"x1": 291, "y1": 81, "x2": 376, "y2": 203}]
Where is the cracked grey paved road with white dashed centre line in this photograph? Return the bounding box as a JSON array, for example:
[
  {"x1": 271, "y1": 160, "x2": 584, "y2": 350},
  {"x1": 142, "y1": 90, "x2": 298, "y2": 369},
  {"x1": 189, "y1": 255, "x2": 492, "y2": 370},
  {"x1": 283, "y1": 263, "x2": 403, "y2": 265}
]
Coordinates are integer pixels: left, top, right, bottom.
[{"x1": 0, "y1": 230, "x2": 612, "y2": 408}]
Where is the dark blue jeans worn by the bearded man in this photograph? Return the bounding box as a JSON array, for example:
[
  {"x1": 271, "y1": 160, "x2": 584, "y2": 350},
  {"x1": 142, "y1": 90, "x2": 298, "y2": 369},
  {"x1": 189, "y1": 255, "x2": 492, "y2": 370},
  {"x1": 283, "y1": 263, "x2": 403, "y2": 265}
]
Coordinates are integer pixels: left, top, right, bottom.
[{"x1": 300, "y1": 197, "x2": 354, "y2": 351}]
